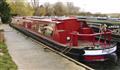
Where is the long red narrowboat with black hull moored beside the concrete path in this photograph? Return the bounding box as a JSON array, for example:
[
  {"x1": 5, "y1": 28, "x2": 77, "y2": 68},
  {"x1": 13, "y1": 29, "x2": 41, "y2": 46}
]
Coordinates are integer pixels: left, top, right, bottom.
[{"x1": 10, "y1": 17, "x2": 117, "y2": 61}]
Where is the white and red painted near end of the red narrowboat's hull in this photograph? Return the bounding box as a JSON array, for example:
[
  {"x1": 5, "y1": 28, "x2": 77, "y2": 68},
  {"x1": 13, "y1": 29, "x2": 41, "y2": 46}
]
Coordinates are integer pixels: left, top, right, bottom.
[{"x1": 84, "y1": 46, "x2": 117, "y2": 61}]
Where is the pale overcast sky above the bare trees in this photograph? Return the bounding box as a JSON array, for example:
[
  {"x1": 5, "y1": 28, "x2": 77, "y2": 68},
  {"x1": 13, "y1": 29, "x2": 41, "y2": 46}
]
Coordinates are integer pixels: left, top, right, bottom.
[{"x1": 28, "y1": 0, "x2": 120, "y2": 14}]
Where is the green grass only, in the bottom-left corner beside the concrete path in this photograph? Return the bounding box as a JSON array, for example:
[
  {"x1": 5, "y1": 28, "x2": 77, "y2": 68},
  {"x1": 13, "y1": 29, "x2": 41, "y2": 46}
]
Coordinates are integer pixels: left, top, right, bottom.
[{"x1": 0, "y1": 43, "x2": 17, "y2": 70}]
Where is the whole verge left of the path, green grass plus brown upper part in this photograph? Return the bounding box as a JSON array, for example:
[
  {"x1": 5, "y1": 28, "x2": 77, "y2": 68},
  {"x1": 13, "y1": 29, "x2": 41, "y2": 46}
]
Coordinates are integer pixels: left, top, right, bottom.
[{"x1": 0, "y1": 25, "x2": 17, "y2": 70}]
